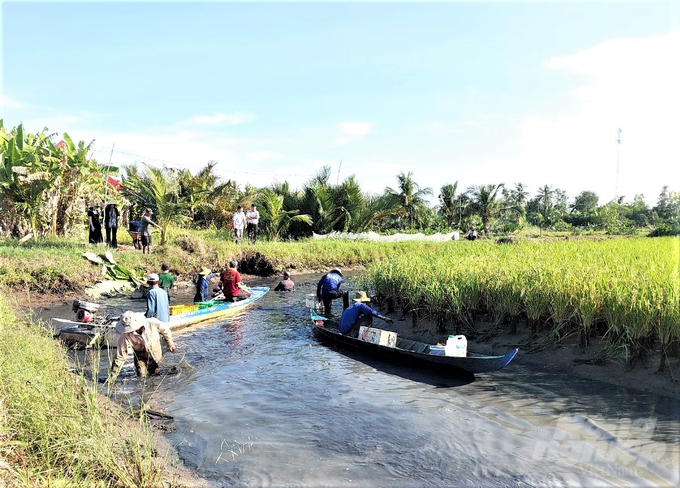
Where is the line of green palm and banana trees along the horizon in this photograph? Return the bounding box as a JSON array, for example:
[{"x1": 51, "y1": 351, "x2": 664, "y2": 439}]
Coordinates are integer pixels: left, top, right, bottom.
[{"x1": 0, "y1": 120, "x2": 680, "y2": 242}]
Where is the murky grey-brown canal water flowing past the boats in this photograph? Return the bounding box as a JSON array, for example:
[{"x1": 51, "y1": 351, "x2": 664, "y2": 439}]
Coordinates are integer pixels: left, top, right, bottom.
[{"x1": 51, "y1": 277, "x2": 680, "y2": 487}]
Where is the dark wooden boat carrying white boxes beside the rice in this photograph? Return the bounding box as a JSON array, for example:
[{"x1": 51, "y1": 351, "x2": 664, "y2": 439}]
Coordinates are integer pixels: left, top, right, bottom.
[{"x1": 310, "y1": 310, "x2": 518, "y2": 373}]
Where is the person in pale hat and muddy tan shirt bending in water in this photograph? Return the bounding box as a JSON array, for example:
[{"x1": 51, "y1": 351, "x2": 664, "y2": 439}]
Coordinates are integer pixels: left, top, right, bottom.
[{"x1": 109, "y1": 310, "x2": 175, "y2": 383}]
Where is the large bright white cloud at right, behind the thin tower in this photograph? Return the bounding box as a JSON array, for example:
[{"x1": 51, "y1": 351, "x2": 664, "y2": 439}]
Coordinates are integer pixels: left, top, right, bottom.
[{"x1": 488, "y1": 32, "x2": 680, "y2": 203}]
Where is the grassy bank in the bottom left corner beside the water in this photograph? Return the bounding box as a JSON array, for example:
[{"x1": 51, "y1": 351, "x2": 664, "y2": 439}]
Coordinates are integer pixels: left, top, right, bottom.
[{"x1": 0, "y1": 299, "x2": 164, "y2": 487}]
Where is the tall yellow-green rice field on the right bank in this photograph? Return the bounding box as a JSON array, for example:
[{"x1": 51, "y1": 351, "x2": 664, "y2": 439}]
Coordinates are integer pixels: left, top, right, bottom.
[{"x1": 363, "y1": 237, "x2": 680, "y2": 368}]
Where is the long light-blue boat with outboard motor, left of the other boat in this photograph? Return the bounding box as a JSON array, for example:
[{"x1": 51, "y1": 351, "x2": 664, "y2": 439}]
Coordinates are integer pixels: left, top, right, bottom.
[{"x1": 52, "y1": 286, "x2": 269, "y2": 347}]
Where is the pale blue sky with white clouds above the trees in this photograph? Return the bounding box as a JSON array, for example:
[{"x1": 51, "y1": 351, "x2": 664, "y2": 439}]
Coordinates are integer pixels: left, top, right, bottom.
[{"x1": 0, "y1": 0, "x2": 680, "y2": 205}]
